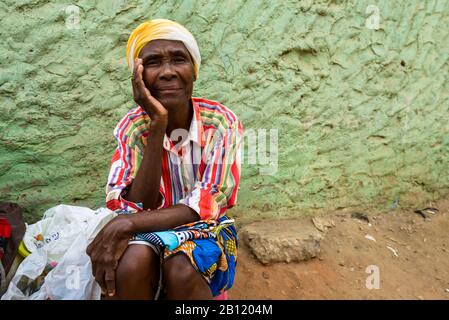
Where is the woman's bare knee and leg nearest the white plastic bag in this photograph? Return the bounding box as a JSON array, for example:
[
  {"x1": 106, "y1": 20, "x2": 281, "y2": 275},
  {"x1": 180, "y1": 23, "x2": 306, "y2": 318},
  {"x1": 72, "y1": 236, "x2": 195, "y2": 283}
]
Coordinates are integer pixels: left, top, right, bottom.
[{"x1": 106, "y1": 244, "x2": 160, "y2": 300}]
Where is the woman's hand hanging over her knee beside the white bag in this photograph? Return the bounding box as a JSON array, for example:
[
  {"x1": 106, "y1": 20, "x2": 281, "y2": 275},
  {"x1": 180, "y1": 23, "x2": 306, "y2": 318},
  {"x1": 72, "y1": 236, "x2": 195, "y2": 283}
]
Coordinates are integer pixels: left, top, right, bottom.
[{"x1": 86, "y1": 215, "x2": 133, "y2": 296}]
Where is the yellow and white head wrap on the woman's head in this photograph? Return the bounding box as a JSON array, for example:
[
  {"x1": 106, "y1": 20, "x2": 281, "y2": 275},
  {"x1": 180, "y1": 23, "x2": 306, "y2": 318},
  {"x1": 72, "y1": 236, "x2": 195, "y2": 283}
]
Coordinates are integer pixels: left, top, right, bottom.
[{"x1": 126, "y1": 19, "x2": 201, "y2": 78}]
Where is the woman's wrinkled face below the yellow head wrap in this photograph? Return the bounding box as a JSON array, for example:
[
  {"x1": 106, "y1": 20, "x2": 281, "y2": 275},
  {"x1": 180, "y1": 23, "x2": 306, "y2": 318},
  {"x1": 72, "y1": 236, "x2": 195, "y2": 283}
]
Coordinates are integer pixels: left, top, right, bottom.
[{"x1": 139, "y1": 40, "x2": 195, "y2": 109}]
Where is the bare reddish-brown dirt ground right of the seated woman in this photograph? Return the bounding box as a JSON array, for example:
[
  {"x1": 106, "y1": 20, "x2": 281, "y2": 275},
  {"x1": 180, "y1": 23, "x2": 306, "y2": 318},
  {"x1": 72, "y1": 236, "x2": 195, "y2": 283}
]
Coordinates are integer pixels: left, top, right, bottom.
[{"x1": 229, "y1": 200, "x2": 449, "y2": 299}]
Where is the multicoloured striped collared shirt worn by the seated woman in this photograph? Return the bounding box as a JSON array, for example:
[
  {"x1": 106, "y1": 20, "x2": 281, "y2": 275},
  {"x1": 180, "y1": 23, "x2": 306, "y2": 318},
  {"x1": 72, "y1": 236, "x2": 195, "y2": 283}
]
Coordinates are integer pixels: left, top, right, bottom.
[{"x1": 106, "y1": 98, "x2": 243, "y2": 220}]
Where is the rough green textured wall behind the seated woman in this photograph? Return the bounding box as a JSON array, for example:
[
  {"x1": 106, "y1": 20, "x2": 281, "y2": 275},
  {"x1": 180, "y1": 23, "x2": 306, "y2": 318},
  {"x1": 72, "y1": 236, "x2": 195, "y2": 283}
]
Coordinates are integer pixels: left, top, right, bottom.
[{"x1": 0, "y1": 0, "x2": 449, "y2": 220}]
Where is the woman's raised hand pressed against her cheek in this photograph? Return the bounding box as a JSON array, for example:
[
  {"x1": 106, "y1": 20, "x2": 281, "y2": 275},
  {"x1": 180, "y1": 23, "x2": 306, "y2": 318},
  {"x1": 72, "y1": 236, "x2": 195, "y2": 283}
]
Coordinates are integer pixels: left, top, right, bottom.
[{"x1": 131, "y1": 58, "x2": 168, "y2": 127}]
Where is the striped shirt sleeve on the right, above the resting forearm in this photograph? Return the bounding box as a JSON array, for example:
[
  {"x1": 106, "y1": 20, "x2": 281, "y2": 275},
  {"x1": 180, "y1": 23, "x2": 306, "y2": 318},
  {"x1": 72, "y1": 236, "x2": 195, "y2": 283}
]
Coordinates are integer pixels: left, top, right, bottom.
[{"x1": 179, "y1": 120, "x2": 243, "y2": 220}]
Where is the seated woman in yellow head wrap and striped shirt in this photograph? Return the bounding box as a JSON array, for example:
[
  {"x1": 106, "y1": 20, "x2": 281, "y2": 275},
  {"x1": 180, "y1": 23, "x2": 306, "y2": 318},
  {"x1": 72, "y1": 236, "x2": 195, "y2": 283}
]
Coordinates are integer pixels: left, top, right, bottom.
[{"x1": 87, "y1": 19, "x2": 242, "y2": 299}]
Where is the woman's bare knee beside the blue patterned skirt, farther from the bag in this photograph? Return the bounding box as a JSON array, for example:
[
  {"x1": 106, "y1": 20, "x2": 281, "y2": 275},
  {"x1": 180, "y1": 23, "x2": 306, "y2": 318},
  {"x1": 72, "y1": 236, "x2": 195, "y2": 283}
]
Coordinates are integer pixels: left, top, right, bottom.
[{"x1": 163, "y1": 253, "x2": 213, "y2": 300}]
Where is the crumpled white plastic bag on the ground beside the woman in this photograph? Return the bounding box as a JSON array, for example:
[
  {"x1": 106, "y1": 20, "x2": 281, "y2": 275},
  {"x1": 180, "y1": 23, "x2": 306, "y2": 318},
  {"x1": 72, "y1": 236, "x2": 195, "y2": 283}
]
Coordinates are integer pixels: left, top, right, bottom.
[{"x1": 1, "y1": 205, "x2": 116, "y2": 300}]
